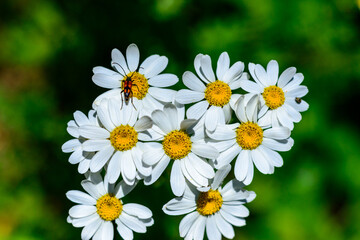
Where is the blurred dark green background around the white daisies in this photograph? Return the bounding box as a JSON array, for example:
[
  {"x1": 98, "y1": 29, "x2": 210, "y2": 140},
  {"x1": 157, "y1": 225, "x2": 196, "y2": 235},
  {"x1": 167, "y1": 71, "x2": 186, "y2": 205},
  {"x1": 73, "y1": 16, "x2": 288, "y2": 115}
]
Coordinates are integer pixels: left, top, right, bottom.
[{"x1": 0, "y1": 0, "x2": 360, "y2": 240}]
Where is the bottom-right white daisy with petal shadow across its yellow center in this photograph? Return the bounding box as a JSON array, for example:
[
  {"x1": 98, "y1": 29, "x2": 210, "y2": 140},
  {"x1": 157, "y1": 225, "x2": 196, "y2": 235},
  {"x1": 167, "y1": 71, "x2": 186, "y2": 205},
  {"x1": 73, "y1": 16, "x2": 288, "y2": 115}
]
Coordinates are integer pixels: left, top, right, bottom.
[{"x1": 163, "y1": 165, "x2": 256, "y2": 240}]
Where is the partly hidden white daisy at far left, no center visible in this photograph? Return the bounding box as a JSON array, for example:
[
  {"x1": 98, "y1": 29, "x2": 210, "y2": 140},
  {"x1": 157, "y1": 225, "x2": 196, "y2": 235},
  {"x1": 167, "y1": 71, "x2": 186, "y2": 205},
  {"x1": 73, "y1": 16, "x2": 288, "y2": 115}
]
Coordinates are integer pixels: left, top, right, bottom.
[{"x1": 61, "y1": 110, "x2": 99, "y2": 174}]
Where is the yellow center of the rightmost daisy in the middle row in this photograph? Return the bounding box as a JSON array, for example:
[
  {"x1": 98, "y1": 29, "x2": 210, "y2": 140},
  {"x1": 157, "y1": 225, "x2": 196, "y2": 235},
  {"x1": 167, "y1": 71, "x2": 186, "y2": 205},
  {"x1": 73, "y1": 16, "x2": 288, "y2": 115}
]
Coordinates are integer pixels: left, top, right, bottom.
[{"x1": 236, "y1": 122, "x2": 263, "y2": 150}]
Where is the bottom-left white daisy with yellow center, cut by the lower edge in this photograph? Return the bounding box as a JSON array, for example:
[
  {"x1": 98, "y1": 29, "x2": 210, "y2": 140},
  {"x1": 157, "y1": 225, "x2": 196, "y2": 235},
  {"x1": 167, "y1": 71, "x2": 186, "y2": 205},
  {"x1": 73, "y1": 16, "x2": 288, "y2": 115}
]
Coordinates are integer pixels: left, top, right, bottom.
[{"x1": 66, "y1": 174, "x2": 154, "y2": 240}]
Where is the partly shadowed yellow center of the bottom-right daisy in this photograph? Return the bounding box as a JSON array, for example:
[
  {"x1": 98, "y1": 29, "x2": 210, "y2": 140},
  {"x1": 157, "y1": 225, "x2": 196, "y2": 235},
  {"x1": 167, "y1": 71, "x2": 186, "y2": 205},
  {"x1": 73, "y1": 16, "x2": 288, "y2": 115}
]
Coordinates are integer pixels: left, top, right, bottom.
[{"x1": 196, "y1": 189, "x2": 223, "y2": 216}]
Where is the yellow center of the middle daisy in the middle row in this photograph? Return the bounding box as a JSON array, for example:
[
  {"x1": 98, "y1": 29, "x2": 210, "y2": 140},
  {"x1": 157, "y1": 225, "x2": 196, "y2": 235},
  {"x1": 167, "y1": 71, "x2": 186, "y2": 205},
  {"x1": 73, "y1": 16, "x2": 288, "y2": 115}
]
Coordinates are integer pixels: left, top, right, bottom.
[{"x1": 162, "y1": 130, "x2": 191, "y2": 159}]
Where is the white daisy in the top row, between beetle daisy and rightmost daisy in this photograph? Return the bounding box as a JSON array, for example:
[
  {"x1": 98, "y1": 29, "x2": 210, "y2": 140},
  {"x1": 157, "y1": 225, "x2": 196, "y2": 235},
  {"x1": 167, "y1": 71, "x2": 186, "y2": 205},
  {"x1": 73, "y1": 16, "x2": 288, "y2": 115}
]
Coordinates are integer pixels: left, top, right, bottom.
[{"x1": 175, "y1": 52, "x2": 248, "y2": 131}]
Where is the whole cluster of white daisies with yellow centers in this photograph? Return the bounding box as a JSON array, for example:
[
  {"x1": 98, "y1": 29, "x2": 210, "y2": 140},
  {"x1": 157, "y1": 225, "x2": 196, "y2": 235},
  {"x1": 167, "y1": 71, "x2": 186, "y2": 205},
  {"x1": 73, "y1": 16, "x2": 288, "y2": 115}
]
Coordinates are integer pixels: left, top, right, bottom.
[{"x1": 62, "y1": 44, "x2": 308, "y2": 240}]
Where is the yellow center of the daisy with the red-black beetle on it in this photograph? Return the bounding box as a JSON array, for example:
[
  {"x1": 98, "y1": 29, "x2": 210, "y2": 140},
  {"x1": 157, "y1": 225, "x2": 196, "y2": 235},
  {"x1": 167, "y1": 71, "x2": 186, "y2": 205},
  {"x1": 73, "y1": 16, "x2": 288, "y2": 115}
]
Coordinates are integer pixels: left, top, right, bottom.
[{"x1": 121, "y1": 72, "x2": 149, "y2": 99}]
